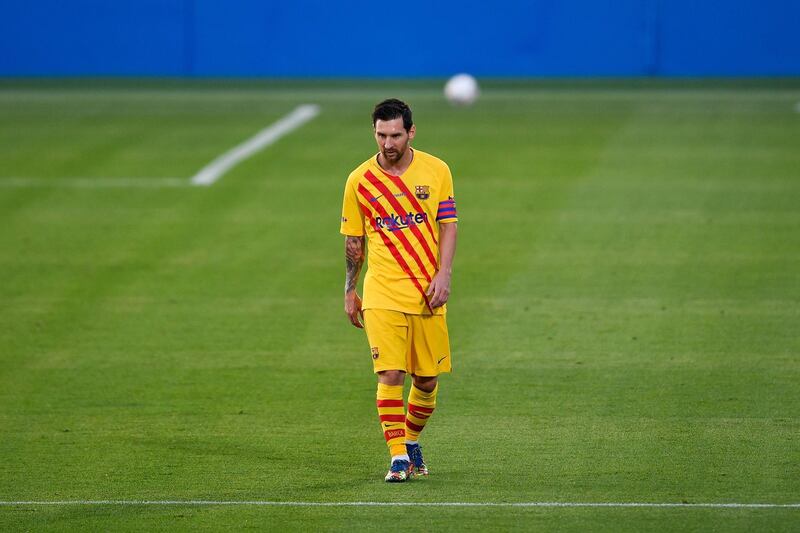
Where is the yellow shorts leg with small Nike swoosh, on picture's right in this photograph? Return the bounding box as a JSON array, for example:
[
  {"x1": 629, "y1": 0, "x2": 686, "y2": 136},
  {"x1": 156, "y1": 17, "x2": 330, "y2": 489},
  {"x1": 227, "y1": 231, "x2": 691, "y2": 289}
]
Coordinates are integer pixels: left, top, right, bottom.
[{"x1": 408, "y1": 315, "x2": 452, "y2": 376}]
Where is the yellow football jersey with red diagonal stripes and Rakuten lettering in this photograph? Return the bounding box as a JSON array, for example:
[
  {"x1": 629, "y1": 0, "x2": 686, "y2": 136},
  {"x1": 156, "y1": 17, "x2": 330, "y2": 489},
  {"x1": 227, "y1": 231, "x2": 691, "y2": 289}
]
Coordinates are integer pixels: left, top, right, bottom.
[{"x1": 340, "y1": 150, "x2": 458, "y2": 315}]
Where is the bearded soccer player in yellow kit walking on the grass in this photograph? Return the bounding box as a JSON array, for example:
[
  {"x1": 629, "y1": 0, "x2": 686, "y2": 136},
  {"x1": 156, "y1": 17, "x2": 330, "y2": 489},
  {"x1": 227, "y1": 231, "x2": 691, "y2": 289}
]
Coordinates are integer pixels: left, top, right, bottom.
[{"x1": 341, "y1": 99, "x2": 458, "y2": 482}]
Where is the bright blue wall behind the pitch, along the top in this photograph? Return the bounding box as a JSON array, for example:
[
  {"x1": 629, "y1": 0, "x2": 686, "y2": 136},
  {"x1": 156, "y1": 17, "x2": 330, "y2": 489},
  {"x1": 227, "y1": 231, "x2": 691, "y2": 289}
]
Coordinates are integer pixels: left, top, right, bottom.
[{"x1": 0, "y1": 0, "x2": 800, "y2": 77}]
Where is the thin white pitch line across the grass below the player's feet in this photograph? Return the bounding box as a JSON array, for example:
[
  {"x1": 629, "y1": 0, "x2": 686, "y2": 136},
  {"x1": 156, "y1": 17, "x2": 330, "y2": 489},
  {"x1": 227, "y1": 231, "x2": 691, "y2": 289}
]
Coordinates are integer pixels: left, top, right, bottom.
[{"x1": 0, "y1": 500, "x2": 800, "y2": 509}]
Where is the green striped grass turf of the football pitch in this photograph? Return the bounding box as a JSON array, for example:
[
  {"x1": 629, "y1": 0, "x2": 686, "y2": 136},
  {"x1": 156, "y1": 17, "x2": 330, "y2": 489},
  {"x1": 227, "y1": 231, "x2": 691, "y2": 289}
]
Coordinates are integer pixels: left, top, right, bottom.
[{"x1": 0, "y1": 78, "x2": 800, "y2": 531}]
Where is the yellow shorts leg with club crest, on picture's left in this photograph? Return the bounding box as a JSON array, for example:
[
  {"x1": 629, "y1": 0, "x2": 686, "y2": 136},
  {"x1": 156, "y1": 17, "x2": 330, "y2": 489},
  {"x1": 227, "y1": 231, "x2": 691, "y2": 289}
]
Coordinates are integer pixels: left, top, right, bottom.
[{"x1": 364, "y1": 309, "x2": 409, "y2": 372}]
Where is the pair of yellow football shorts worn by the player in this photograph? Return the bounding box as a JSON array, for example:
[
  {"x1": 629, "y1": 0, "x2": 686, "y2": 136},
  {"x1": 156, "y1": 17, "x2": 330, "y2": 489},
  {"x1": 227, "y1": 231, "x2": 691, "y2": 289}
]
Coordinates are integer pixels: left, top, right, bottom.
[{"x1": 364, "y1": 309, "x2": 450, "y2": 377}]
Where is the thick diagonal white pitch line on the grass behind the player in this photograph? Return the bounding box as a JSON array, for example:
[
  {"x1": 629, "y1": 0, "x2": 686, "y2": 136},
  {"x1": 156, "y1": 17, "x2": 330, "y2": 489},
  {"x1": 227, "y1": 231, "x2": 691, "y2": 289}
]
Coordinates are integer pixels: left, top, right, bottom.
[{"x1": 192, "y1": 104, "x2": 319, "y2": 186}]
